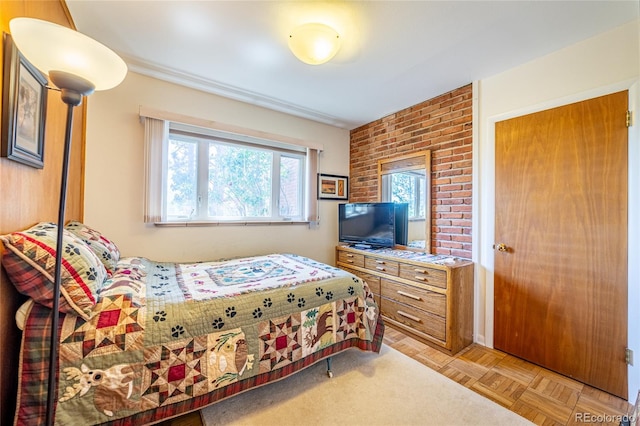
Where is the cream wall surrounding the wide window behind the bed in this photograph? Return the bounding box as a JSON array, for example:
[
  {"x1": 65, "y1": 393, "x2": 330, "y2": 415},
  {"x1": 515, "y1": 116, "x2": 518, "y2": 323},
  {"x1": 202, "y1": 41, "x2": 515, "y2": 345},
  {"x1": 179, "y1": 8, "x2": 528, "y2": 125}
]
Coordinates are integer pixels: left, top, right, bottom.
[{"x1": 84, "y1": 72, "x2": 349, "y2": 264}]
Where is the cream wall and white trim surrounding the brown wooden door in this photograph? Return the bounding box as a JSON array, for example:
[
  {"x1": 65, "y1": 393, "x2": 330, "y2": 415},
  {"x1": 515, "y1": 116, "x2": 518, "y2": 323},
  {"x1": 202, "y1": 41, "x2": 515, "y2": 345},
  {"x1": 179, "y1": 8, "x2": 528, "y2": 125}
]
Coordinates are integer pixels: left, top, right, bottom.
[{"x1": 473, "y1": 21, "x2": 640, "y2": 400}]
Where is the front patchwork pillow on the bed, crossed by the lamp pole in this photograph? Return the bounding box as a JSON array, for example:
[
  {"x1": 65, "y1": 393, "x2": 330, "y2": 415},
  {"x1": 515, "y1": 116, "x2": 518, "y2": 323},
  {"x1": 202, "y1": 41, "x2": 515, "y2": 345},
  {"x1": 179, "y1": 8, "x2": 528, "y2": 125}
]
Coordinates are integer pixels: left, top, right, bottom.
[{"x1": 0, "y1": 222, "x2": 107, "y2": 320}]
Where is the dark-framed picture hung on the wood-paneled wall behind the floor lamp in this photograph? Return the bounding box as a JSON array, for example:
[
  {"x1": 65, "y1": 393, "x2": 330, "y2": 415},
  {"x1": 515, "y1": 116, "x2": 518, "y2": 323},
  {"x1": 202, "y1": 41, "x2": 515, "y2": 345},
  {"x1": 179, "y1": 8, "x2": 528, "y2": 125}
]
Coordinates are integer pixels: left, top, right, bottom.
[{"x1": 0, "y1": 33, "x2": 47, "y2": 169}]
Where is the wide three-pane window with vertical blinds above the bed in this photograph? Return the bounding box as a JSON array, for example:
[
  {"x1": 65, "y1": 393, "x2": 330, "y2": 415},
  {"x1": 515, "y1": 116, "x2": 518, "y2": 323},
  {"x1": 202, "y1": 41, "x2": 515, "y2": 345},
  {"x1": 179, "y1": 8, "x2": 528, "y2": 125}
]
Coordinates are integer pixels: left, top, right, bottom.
[{"x1": 144, "y1": 116, "x2": 318, "y2": 225}]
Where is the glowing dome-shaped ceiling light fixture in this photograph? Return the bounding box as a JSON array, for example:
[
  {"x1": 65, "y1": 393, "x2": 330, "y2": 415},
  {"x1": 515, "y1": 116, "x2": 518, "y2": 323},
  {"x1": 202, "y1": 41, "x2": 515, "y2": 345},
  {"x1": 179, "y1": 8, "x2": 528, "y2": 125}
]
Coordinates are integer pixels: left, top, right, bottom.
[{"x1": 289, "y1": 23, "x2": 340, "y2": 65}]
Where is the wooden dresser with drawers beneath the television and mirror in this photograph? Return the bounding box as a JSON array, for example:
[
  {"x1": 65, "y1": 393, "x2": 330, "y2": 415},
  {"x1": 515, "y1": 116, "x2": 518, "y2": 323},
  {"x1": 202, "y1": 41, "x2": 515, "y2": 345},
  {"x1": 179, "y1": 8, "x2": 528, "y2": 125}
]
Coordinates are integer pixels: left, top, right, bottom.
[{"x1": 336, "y1": 245, "x2": 473, "y2": 355}]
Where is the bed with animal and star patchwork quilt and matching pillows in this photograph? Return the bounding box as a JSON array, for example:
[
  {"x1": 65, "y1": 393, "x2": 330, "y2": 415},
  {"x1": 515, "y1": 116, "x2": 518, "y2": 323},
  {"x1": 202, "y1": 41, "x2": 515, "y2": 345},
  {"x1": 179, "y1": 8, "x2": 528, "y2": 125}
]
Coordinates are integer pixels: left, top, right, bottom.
[{"x1": 0, "y1": 222, "x2": 384, "y2": 425}]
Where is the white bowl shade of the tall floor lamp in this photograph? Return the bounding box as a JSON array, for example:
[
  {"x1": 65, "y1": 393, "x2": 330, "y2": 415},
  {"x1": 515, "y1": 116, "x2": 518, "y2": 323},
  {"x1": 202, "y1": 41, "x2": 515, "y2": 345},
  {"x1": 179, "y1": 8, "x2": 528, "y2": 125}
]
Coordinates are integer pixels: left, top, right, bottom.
[{"x1": 9, "y1": 18, "x2": 127, "y2": 90}]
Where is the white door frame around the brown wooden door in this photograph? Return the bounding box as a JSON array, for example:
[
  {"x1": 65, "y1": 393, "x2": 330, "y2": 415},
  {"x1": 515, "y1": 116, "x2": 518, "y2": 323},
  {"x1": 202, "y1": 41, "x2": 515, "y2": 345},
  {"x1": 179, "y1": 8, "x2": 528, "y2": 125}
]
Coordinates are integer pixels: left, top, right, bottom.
[{"x1": 472, "y1": 79, "x2": 640, "y2": 401}]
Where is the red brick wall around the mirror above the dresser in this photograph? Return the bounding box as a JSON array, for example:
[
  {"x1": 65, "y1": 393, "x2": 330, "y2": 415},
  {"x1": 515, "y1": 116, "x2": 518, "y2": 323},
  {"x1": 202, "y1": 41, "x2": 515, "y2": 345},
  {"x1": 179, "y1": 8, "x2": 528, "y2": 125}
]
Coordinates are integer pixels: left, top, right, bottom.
[{"x1": 349, "y1": 84, "x2": 472, "y2": 258}]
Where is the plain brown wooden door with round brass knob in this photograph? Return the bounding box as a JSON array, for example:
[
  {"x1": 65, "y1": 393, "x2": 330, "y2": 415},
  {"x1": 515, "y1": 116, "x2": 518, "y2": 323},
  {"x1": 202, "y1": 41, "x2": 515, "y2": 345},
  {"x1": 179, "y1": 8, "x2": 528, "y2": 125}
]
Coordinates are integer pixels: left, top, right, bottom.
[{"x1": 494, "y1": 91, "x2": 628, "y2": 399}]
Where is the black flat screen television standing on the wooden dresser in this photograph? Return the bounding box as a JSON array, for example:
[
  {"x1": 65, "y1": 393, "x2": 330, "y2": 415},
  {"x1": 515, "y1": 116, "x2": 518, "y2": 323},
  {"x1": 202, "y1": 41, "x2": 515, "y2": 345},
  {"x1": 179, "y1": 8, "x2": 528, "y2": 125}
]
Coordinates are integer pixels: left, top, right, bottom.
[{"x1": 338, "y1": 203, "x2": 396, "y2": 247}]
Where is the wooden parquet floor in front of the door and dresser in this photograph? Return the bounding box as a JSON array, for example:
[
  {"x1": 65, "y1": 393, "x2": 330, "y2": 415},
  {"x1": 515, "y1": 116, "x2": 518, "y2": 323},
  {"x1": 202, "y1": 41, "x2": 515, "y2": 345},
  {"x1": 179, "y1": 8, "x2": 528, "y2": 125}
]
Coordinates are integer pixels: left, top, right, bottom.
[{"x1": 162, "y1": 326, "x2": 632, "y2": 426}]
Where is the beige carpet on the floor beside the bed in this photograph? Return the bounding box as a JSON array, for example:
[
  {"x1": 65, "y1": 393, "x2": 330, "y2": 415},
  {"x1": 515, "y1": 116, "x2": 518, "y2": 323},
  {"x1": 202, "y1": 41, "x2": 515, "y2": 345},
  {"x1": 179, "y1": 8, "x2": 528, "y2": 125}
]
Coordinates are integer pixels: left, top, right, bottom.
[{"x1": 201, "y1": 345, "x2": 532, "y2": 426}]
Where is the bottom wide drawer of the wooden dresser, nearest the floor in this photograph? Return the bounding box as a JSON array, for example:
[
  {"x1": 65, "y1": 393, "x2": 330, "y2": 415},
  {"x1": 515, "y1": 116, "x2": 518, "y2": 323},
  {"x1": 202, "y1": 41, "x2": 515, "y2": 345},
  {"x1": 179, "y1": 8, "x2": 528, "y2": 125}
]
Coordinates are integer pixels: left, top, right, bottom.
[{"x1": 380, "y1": 297, "x2": 446, "y2": 342}]
